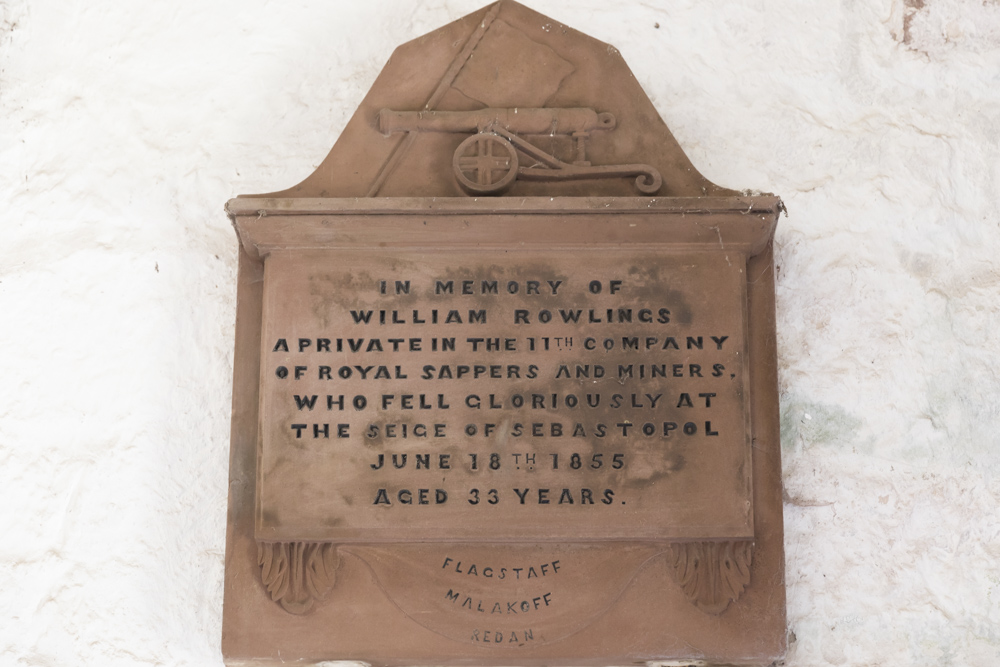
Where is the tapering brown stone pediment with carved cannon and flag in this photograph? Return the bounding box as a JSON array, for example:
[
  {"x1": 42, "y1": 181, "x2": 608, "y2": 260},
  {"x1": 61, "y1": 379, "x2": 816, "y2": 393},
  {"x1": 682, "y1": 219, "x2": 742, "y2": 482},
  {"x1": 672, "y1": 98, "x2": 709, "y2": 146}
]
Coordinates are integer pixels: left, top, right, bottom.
[{"x1": 246, "y1": 0, "x2": 735, "y2": 198}]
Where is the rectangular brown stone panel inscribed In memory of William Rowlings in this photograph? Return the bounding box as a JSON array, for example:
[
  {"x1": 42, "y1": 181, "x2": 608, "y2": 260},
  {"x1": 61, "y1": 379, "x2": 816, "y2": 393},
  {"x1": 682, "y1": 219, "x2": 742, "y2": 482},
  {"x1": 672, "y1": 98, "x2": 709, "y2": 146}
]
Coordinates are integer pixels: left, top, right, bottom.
[{"x1": 256, "y1": 248, "x2": 753, "y2": 542}]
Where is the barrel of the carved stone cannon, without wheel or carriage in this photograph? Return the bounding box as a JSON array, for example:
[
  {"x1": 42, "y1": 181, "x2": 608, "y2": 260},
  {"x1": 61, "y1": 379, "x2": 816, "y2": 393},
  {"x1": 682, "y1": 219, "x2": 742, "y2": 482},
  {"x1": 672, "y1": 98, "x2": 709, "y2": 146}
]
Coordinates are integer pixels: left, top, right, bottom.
[{"x1": 378, "y1": 107, "x2": 615, "y2": 135}]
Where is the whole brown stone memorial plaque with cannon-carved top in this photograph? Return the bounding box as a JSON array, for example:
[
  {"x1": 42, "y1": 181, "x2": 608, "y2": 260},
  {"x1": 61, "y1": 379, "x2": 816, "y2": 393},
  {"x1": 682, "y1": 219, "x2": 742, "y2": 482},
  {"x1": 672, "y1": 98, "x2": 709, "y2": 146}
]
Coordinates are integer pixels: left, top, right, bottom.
[{"x1": 223, "y1": 0, "x2": 785, "y2": 665}]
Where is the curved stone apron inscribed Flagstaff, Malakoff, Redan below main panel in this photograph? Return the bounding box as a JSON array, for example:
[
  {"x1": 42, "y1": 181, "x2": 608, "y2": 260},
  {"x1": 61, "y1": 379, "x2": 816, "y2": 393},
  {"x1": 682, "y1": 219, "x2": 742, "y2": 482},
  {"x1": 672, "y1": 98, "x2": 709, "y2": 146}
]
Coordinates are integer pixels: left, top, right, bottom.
[{"x1": 343, "y1": 544, "x2": 667, "y2": 649}]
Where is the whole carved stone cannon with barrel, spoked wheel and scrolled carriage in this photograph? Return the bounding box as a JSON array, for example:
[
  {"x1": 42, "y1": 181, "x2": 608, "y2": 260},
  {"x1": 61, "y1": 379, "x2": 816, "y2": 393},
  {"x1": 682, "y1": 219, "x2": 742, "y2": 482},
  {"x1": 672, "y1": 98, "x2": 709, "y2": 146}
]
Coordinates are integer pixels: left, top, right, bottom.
[{"x1": 378, "y1": 107, "x2": 663, "y2": 194}]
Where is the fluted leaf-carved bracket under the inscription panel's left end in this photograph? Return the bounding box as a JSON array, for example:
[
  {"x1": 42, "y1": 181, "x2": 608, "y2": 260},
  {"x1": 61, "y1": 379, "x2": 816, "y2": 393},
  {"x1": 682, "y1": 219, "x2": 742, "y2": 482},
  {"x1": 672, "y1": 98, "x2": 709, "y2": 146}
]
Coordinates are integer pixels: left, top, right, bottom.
[{"x1": 257, "y1": 542, "x2": 340, "y2": 614}]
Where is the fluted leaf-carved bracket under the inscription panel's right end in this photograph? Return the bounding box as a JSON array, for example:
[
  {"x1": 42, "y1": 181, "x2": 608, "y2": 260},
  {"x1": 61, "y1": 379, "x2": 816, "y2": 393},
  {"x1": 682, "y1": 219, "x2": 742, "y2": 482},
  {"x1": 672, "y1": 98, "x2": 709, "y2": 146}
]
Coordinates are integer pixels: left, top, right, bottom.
[{"x1": 667, "y1": 541, "x2": 753, "y2": 615}]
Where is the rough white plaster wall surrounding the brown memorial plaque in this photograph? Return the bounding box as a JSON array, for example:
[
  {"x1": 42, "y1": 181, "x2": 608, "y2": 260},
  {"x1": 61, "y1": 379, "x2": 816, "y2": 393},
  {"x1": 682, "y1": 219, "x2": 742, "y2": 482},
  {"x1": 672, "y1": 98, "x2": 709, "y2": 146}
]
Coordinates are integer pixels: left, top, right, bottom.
[{"x1": 0, "y1": 0, "x2": 1000, "y2": 667}]
